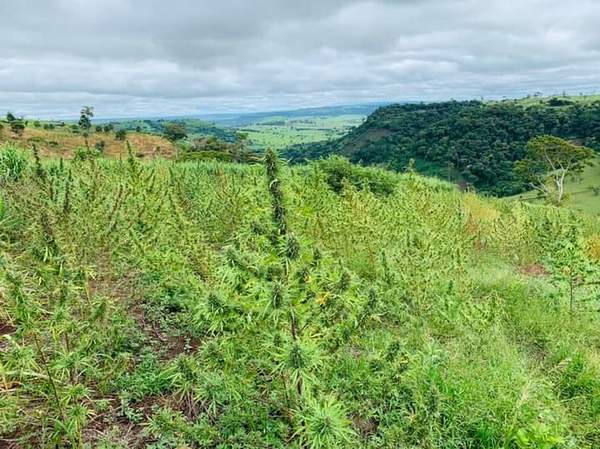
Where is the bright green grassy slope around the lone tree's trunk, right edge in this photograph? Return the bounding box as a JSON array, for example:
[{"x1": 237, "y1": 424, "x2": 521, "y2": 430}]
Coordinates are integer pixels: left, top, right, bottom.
[{"x1": 513, "y1": 158, "x2": 600, "y2": 215}]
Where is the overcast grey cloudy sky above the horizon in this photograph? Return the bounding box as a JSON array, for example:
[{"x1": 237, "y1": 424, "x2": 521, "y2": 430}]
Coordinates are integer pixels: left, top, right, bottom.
[{"x1": 0, "y1": 0, "x2": 600, "y2": 118}]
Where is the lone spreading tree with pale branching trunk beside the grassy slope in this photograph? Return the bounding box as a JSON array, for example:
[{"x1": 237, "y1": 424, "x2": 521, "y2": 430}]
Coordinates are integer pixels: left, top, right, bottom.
[{"x1": 515, "y1": 136, "x2": 594, "y2": 205}]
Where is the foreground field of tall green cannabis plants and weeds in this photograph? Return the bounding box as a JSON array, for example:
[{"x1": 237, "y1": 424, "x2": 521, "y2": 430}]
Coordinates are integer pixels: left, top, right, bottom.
[{"x1": 0, "y1": 147, "x2": 600, "y2": 449}]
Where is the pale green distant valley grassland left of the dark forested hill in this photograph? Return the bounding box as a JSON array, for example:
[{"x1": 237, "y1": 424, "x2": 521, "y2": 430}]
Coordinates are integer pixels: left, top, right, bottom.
[{"x1": 240, "y1": 115, "x2": 363, "y2": 149}]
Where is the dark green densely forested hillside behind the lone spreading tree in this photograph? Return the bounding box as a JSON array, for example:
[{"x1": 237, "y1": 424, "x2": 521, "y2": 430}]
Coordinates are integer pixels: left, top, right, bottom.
[{"x1": 287, "y1": 99, "x2": 600, "y2": 195}]
